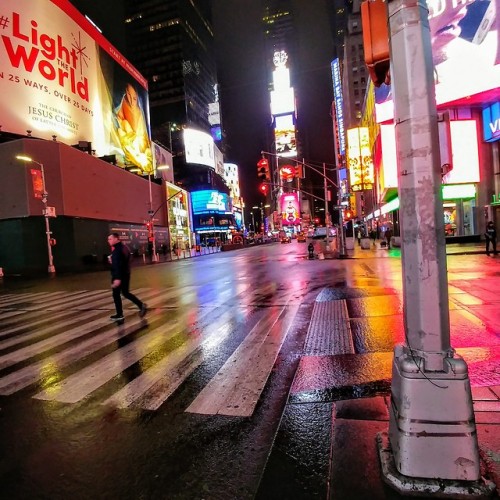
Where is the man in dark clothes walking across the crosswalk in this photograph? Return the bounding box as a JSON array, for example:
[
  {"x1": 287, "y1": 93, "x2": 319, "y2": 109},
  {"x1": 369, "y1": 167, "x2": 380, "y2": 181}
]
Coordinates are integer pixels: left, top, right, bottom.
[{"x1": 108, "y1": 233, "x2": 148, "y2": 321}]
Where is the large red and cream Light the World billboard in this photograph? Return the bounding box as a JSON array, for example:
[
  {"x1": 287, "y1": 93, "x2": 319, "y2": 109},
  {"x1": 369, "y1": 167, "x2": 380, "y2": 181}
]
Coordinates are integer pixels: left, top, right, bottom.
[{"x1": 0, "y1": 0, "x2": 153, "y2": 173}]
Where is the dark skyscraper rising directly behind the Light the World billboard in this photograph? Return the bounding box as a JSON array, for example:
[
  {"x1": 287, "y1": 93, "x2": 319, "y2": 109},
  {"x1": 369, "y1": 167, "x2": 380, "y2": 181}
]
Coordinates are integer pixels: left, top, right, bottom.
[{"x1": 124, "y1": 0, "x2": 217, "y2": 146}]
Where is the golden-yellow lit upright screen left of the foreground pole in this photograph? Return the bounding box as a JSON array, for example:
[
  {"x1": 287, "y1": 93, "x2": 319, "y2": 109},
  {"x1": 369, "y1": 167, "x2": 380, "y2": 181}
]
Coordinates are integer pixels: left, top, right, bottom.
[{"x1": 347, "y1": 127, "x2": 374, "y2": 191}]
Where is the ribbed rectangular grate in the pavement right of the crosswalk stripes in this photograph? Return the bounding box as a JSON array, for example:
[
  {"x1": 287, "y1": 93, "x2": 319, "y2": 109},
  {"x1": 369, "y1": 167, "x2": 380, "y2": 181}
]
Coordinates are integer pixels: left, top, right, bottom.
[{"x1": 304, "y1": 300, "x2": 354, "y2": 356}]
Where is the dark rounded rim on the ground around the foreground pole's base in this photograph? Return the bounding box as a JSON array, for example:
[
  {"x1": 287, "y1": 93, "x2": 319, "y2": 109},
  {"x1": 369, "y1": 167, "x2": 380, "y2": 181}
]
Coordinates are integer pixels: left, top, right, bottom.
[{"x1": 376, "y1": 432, "x2": 495, "y2": 499}]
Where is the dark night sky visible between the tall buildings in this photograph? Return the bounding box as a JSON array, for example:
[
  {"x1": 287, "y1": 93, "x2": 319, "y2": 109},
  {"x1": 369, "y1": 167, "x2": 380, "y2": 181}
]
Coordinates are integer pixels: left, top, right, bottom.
[{"x1": 67, "y1": 0, "x2": 334, "y2": 209}]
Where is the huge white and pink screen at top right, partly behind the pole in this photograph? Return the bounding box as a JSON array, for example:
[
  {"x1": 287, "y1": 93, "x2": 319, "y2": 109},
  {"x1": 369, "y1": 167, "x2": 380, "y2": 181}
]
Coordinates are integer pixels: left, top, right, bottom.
[{"x1": 375, "y1": 0, "x2": 500, "y2": 123}]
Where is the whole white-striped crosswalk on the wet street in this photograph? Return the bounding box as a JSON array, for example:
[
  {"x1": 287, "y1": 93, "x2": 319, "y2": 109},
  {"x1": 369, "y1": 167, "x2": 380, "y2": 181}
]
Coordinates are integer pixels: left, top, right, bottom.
[{"x1": 0, "y1": 283, "x2": 298, "y2": 417}]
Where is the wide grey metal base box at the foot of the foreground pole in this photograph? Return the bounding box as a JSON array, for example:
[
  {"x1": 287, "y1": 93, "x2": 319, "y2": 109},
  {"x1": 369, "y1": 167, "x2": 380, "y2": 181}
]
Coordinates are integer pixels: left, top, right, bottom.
[{"x1": 389, "y1": 346, "x2": 480, "y2": 481}]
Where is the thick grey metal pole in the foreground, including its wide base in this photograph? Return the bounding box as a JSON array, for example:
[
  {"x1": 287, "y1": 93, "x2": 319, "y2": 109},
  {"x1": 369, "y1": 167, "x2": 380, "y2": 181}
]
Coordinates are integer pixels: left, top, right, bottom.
[{"x1": 379, "y1": 0, "x2": 490, "y2": 491}]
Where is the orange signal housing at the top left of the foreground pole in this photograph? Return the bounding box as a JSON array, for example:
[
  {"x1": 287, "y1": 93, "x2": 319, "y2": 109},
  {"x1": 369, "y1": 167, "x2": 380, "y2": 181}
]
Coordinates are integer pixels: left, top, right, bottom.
[{"x1": 361, "y1": 0, "x2": 391, "y2": 87}]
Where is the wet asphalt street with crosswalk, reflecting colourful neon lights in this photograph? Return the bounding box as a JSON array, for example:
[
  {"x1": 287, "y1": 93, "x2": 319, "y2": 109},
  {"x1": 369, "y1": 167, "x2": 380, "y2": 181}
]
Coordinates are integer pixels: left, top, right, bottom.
[{"x1": 0, "y1": 241, "x2": 500, "y2": 499}]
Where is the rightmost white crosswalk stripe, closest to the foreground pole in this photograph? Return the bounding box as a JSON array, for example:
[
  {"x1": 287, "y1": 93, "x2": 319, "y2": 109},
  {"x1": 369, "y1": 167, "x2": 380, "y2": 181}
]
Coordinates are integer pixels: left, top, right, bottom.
[{"x1": 186, "y1": 305, "x2": 299, "y2": 417}]
